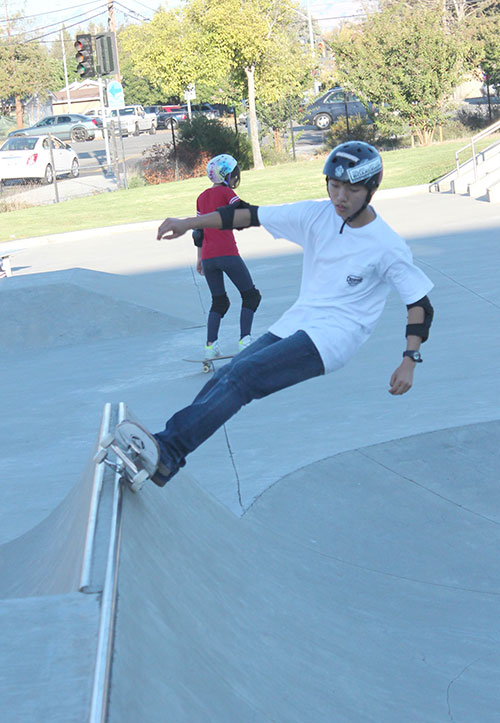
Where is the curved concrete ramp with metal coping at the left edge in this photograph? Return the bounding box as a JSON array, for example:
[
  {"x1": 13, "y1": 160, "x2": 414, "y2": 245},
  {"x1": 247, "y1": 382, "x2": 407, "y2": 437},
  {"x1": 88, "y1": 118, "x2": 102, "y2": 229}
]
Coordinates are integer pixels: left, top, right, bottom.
[{"x1": 0, "y1": 405, "x2": 118, "y2": 723}]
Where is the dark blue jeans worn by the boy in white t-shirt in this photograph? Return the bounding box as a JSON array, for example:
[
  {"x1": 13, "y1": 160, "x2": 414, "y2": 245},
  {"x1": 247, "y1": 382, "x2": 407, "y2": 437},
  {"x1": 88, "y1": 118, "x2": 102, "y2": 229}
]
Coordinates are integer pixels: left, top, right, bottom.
[{"x1": 154, "y1": 331, "x2": 325, "y2": 479}]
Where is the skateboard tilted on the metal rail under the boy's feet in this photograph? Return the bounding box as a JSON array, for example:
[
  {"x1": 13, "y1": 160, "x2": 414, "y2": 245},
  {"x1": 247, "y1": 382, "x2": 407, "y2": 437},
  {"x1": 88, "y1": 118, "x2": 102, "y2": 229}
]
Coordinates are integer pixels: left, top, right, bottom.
[{"x1": 94, "y1": 419, "x2": 160, "y2": 492}]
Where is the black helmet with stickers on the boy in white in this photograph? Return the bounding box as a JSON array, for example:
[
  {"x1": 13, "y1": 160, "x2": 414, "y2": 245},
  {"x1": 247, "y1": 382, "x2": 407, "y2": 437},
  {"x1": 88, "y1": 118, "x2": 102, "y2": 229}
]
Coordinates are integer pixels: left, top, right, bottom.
[{"x1": 323, "y1": 141, "x2": 382, "y2": 193}]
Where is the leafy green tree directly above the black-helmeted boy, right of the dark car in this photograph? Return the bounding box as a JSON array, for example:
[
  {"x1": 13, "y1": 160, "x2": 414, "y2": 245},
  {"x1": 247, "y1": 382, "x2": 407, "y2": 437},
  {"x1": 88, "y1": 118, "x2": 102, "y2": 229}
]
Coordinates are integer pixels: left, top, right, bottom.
[{"x1": 332, "y1": 0, "x2": 471, "y2": 145}]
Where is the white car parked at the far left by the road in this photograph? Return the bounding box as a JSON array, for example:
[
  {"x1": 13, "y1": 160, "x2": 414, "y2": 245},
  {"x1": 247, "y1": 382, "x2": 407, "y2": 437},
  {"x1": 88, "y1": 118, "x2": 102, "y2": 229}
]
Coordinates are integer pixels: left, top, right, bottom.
[{"x1": 0, "y1": 136, "x2": 80, "y2": 184}]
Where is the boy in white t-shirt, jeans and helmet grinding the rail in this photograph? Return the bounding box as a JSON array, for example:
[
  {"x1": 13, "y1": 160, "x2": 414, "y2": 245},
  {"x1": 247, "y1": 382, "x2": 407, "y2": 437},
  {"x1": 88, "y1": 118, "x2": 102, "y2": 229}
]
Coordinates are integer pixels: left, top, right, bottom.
[{"x1": 109, "y1": 141, "x2": 433, "y2": 486}]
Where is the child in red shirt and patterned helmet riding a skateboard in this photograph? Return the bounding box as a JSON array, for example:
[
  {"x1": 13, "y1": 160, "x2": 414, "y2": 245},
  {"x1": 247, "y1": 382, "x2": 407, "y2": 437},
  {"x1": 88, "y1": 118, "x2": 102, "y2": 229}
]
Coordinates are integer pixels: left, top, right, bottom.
[{"x1": 193, "y1": 153, "x2": 261, "y2": 359}]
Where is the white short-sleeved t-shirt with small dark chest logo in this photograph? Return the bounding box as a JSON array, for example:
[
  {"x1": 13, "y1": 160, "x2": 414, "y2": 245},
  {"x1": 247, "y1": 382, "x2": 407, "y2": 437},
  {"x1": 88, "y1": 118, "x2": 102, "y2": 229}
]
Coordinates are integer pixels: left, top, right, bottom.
[{"x1": 258, "y1": 199, "x2": 433, "y2": 373}]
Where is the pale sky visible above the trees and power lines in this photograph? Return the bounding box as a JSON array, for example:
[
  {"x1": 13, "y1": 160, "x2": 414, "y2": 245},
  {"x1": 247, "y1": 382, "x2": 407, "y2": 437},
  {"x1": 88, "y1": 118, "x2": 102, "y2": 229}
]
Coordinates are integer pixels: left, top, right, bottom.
[{"x1": 0, "y1": 0, "x2": 360, "y2": 40}]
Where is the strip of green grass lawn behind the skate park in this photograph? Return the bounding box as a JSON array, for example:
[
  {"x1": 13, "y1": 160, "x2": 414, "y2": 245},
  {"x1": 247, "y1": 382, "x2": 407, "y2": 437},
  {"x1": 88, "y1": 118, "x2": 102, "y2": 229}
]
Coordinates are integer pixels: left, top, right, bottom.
[{"x1": 0, "y1": 136, "x2": 492, "y2": 242}]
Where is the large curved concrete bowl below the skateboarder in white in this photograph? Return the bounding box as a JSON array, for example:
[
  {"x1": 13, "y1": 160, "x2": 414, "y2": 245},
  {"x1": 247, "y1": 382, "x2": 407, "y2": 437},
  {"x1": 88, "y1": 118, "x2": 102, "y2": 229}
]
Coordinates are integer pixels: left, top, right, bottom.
[{"x1": 108, "y1": 422, "x2": 500, "y2": 723}]
